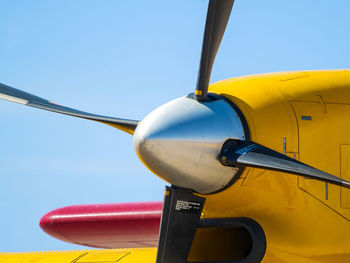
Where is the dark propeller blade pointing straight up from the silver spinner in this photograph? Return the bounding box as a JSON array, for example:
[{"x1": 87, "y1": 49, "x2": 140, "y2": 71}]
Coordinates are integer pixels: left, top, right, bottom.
[{"x1": 195, "y1": 0, "x2": 234, "y2": 100}]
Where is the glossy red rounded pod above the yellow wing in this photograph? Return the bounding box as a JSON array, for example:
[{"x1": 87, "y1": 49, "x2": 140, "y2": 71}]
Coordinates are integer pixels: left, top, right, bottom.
[{"x1": 39, "y1": 202, "x2": 163, "y2": 248}]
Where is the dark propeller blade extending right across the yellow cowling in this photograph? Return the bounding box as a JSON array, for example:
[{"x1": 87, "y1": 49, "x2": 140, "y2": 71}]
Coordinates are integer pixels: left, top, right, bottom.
[{"x1": 219, "y1": 140, "x2": 350, "y2": 188}]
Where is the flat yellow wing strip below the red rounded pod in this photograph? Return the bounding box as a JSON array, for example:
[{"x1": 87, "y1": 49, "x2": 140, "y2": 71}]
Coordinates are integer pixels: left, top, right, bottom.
[{"x1": 0, "y1": 248, "x2": 157, "y2": 263}]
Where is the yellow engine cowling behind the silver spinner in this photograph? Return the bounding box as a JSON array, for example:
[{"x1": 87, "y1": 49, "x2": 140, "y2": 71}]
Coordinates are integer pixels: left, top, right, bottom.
[{"x1": 203, "y1": 70, "x2": 350, "y2": 263}]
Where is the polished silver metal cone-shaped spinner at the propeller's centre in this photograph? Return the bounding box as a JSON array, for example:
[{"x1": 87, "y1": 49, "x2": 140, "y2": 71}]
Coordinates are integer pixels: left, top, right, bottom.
[{"x1": 134, "y1": 97, "x2": 245, "y2": 194}]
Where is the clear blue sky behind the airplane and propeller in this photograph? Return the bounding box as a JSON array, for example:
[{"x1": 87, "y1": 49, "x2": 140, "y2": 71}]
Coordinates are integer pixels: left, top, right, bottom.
[{"x1": 0, "y1": 0, "x2": 350, "y2": 254}]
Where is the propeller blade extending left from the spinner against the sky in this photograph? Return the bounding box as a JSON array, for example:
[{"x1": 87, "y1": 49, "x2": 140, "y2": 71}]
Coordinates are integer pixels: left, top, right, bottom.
[{"x1": 0, "y1": 83, "x2": 138, "y2": 134}]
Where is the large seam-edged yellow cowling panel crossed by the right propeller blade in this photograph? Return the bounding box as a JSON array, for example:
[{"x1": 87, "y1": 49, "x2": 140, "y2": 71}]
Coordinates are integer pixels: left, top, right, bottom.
[{"x1": 291, "y1": 100, "x2": 350, "y2": 219}]
